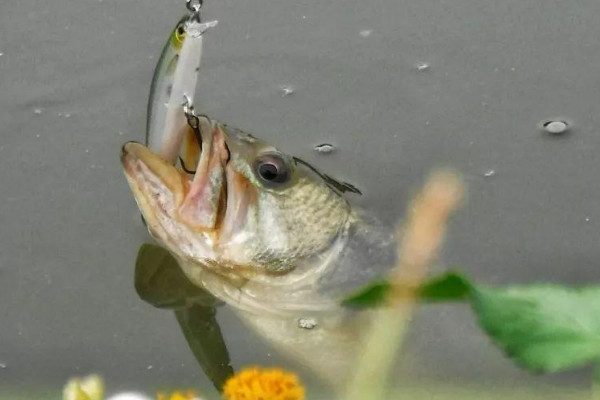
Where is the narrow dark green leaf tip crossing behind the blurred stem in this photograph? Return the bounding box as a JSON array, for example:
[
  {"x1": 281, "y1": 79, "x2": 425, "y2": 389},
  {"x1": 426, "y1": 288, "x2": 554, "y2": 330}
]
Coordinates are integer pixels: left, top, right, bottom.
[{"x1": 342, "y1": 272, "x2": 471, "y2": 308}]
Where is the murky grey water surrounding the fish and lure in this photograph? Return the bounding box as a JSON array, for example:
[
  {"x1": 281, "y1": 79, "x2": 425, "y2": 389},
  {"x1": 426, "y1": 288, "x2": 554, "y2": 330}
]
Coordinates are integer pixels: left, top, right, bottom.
[{"x1": 0, "y1": 0, "x2": 600, "y2": 398}]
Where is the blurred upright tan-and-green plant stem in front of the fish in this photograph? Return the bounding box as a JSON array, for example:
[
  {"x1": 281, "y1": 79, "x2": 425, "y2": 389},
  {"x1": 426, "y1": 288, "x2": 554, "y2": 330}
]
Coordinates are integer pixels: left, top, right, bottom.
[{"x1": 345, "y1": 172, "x2": 462, "y2": 400}]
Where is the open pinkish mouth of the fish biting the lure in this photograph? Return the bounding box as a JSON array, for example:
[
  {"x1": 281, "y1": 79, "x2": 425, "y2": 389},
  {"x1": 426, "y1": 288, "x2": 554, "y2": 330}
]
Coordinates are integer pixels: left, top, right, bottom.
[{"x1": 121, "y1": 118, "x2": 229, "y2": 236}]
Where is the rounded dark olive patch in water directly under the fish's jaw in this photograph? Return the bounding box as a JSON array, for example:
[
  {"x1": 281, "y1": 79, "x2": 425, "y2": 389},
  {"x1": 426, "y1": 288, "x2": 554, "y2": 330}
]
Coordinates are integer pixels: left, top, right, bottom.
[{"x1": 135, "y1": 244, "x2": 217, "y2": 309}]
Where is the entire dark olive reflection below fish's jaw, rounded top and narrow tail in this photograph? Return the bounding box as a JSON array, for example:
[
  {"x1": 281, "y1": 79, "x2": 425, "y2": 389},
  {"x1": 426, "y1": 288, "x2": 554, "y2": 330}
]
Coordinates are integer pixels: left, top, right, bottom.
[{"x1": 135, "y1": 244, "x2": 233, "y2": 390}]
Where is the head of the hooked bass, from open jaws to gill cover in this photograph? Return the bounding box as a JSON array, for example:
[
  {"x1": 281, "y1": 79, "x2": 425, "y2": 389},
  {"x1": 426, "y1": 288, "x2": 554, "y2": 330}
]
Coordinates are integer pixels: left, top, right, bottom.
[{"x1": 121, "y1": 118, "x2": 351, "y2": 274}]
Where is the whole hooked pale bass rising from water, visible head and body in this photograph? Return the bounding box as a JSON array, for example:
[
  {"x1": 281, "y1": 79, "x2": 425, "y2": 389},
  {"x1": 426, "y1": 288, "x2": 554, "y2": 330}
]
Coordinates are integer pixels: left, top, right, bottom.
[{"x1": 121, "y1": 116, "x2": 397, "y2": 387}]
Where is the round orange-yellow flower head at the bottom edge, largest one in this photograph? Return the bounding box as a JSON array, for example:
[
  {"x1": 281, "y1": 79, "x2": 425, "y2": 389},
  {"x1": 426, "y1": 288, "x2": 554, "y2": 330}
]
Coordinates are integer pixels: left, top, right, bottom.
[{"x1": 223, "y1": 367, "x2": 304, "y2": 400}]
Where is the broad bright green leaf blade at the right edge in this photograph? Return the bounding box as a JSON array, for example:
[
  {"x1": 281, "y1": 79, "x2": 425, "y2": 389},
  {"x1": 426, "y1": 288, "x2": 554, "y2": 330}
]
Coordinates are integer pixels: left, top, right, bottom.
[{"x1": 472, "y1": 285, "x2": 600, "y2": 372}]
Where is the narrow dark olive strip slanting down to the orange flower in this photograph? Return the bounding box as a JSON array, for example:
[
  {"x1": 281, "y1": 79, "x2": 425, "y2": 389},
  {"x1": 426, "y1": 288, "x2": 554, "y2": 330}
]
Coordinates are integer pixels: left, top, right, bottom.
[{"x1": 175, "y1": 305, "x2": 233, "y2": 392}]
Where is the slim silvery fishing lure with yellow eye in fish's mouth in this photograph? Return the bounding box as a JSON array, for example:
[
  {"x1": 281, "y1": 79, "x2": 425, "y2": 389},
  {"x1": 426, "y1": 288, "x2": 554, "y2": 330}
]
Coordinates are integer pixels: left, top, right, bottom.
[{"x1": 145, "y1": 15, "x2": 218, "y2": 165}]
